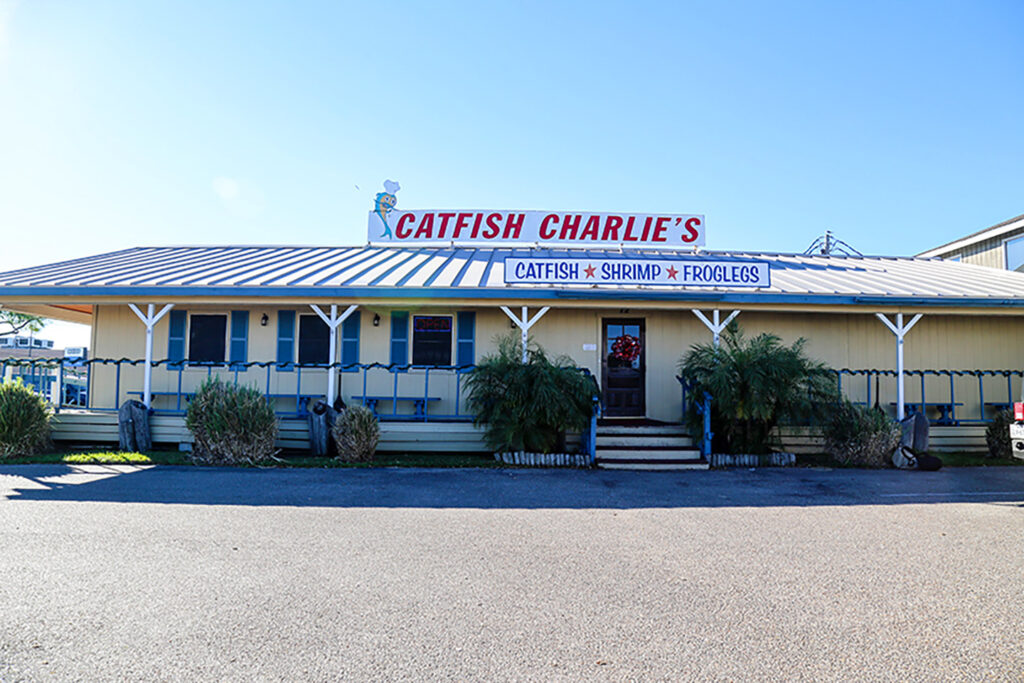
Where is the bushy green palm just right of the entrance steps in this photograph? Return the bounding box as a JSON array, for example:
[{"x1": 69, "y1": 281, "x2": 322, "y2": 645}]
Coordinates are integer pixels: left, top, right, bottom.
[{"x1": 680, "y1": 323, "x2": 839, "y2": 454}]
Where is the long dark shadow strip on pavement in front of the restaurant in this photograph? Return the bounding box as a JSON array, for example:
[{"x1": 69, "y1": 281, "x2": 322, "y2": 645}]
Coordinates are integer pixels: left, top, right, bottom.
[{"x1": 0, "y1": 465, "x2": 1024, "y2": 509}]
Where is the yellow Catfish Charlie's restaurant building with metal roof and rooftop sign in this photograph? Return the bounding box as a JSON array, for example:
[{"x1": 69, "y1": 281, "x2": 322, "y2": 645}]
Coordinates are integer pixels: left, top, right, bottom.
[{"x1": 0, "y1": 208, "x2": 1024, "y2": 465}]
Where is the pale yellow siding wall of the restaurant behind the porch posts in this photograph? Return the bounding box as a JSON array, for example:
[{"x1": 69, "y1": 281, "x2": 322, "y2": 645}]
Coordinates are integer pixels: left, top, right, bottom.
[{"x1": 91, "y1": 305, "x2": 1024, "y2": 421}]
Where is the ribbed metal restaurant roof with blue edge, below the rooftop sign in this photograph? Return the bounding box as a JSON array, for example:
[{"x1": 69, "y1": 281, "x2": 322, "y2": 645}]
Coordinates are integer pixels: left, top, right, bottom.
[{"x1": 0, "y1": 246, "x2": 1024, "y2": 306}]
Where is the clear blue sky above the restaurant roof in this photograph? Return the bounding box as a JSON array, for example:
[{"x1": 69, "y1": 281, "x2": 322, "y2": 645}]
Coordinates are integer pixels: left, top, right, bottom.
[{"x1": 0, "y1": 0, "x2": 1024, "y2": 342}]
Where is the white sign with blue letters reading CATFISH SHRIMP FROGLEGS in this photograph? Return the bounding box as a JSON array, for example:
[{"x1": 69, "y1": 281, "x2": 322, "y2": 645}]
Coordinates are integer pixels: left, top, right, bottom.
[{"x1": 505, "y1": 258, "x2": 771, "y2": 287}]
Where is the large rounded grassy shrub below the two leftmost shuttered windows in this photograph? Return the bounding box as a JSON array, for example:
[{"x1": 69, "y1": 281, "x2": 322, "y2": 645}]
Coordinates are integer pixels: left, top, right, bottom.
[{"x1": 185, "y1": 378, "x2": 278, "y2": 465}]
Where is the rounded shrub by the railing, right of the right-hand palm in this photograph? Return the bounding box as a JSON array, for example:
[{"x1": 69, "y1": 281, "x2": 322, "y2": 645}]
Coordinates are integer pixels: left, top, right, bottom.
[{"x1": 822, "y1": 399, "x2": 901, "y2": 467}]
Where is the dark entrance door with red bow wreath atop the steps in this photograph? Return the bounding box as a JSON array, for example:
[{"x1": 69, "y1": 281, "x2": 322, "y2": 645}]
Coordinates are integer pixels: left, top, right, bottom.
[{"x1": 601, "y1": 318, "x2": 646, "y2": 418}]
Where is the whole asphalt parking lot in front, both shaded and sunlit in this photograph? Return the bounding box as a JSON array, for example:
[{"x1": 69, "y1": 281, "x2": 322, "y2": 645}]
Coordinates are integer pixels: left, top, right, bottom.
[{"x1": 0, "y1": 466, "x2": 1024, "y2": 681}]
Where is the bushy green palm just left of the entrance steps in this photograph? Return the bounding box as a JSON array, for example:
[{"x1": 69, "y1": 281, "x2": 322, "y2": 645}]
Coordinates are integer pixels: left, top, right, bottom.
[{"x1": 466, "y1": 335, "x2": 598, "y2": 453}]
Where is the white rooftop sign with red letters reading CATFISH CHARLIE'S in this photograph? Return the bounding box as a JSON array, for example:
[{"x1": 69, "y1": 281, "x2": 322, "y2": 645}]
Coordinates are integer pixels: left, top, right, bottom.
[{"x1": 368, "y1": 207, "x2": 705, "y2": 249}]
